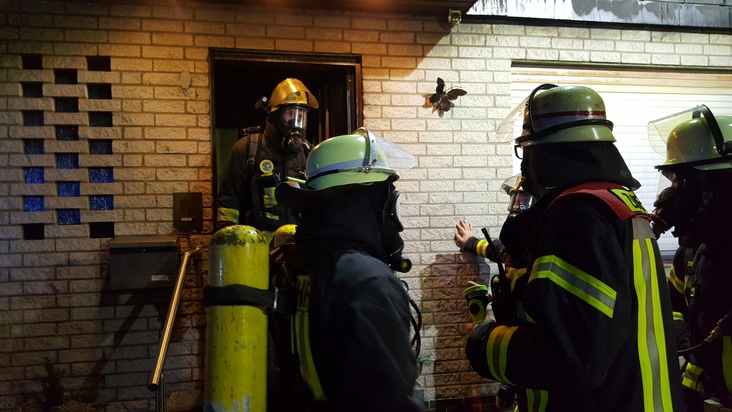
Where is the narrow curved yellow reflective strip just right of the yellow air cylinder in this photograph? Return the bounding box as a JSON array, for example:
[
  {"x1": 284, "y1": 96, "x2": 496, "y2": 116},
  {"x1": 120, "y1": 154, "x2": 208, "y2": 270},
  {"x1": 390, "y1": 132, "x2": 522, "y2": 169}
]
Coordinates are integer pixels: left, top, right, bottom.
[{"x1": 295, "y1": 276, "x2": 327, "y2": 401}]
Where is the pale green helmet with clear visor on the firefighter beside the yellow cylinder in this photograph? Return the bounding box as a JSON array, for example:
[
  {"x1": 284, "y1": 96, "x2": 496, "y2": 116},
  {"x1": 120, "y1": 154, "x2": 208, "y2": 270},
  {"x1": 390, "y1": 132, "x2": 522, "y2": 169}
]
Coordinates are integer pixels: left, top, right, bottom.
[{"x1": 275, "y1": 128, "x2": 415, "y2": 206}]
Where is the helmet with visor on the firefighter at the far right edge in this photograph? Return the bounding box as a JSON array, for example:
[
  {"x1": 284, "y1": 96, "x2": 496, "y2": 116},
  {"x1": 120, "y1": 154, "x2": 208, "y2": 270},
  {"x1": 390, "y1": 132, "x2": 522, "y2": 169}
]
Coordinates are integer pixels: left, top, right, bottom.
[{"x1": 656, "y1": 105, "x2": 732, "y2": 171}]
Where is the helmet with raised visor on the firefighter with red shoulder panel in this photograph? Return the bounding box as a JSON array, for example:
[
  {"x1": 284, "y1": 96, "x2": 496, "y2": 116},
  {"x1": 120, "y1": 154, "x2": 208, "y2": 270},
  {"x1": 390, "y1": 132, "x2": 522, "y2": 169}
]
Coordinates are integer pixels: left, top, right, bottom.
[{"x1": 497, "y1": 84, "x2": 615, "y2": 147}]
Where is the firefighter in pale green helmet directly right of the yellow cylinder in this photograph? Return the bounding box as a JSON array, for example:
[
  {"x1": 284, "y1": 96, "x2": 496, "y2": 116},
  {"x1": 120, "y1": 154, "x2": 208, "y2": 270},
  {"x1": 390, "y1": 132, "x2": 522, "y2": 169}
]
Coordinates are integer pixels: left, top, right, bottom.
[{"x1": 276, "y1": 128, "x2": 424, "y2": 412}]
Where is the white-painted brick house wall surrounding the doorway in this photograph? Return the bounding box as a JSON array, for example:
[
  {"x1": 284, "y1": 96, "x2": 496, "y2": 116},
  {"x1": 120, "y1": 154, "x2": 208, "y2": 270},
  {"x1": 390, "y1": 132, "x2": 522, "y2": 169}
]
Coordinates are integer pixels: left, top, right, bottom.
[{"x1": 0, "y1": 0, "x2": 732, "y2": 411}]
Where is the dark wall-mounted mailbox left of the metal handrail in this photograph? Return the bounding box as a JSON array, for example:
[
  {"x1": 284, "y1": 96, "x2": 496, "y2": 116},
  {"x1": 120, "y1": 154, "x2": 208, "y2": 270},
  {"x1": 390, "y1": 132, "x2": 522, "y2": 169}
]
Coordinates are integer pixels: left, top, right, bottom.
[{"x1": 109, "y1": 235, "x2": 180, "y2": 290}]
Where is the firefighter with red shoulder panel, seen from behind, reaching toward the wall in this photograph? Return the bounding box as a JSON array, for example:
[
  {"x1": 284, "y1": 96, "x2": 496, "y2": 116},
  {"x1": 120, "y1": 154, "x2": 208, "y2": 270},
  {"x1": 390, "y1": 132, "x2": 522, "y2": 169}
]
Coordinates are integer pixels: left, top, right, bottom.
[{"x1": 466, "y1": 84, "x2": 682, "y2": 412}]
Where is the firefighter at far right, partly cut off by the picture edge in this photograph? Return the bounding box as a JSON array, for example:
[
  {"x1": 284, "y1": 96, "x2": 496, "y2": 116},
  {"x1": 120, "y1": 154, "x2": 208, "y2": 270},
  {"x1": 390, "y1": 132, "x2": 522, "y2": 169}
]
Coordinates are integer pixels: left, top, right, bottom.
[{"x1": 649, "y1": 105, "x2": 732, "y2": 412}]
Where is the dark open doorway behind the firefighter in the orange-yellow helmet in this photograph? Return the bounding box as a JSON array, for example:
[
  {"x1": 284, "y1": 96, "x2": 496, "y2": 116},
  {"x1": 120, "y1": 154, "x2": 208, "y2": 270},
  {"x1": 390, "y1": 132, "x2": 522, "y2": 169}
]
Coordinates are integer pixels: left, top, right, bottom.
[{"x1": 209, "y1": 49, "x2": 363, "y2": 227}]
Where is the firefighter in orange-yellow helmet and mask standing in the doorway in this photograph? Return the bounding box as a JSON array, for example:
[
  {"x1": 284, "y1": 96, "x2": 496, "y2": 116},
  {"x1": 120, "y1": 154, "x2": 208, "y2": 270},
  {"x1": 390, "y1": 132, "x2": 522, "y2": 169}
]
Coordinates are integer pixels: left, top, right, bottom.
[{"x1": 215, "y1": 78, "x2": 318, "y2": 237}]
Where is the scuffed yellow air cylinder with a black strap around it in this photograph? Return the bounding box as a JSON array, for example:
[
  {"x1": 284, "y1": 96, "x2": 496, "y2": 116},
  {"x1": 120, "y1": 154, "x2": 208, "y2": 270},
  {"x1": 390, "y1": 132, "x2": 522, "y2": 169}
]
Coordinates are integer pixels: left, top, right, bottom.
[{"x1": 204, "y1": 225, "x2": 269, "y2": 412}]
